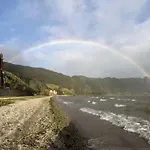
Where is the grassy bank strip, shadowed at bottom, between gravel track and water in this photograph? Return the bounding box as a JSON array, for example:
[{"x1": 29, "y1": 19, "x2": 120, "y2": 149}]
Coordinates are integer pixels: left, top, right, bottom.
[{"x1": 50, "y1": 97, "x2": 88, "y2": 150}]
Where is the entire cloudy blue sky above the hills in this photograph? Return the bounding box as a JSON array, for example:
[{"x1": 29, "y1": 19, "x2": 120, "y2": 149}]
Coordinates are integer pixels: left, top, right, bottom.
[{"x1": 0, "y1": 0, "x2": 150, "y2": 78}]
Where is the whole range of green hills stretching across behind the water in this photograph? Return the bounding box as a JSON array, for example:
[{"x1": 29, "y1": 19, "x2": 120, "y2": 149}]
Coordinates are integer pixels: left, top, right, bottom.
[{"x1": 4, "y1": 63, "x2": 150, "y2": 95}]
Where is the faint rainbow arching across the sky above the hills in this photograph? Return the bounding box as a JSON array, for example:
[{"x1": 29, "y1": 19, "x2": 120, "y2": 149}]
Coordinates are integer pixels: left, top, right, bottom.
[{"x1": 10, "y1": 40, "x2": 150, "y2": 78}]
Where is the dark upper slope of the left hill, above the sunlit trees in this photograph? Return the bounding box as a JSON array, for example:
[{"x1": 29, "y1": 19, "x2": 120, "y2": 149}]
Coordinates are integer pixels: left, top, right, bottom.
[{"x1": 4, "y1": 63, "x2": 72, "y2": 87}]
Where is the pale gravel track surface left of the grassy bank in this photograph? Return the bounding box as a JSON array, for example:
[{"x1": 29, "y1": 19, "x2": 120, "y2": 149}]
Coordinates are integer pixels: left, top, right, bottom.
[{"x1": 0, "y1": 97, "x2": 55, "y2": 150}]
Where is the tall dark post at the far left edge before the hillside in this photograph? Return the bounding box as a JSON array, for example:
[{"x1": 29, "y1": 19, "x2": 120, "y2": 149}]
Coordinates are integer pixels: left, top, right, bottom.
[{"x1": 0, "y1": 53, "x2": 4, "y2": 88}]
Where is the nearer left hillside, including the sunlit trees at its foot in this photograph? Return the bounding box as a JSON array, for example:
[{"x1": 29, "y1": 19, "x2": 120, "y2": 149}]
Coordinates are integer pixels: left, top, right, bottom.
[{"x1": 4, "y1": 62, "x2": 74, "y2": 94}]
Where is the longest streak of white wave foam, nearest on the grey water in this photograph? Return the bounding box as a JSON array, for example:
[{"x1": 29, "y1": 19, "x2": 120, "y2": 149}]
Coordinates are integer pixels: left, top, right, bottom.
[{"x1": 80, "y1": 108, "x2": 150, "y2": 143}]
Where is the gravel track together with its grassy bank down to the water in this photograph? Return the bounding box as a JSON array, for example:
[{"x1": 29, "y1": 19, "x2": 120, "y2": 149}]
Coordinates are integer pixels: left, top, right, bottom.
[{"x1": 0, "y1": 97, "x2": 88, "y2": 150}]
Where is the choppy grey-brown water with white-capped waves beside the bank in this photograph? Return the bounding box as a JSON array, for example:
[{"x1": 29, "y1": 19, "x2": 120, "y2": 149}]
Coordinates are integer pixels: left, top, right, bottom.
[{"x1": 56, "y1": 96, "x2": 150, "y2": 150}]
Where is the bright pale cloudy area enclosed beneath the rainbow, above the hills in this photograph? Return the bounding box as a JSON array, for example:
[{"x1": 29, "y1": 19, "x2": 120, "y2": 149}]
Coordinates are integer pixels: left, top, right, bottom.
[{"x1": 18, "y1": 44, "x2": 143, "y2": 77}]
